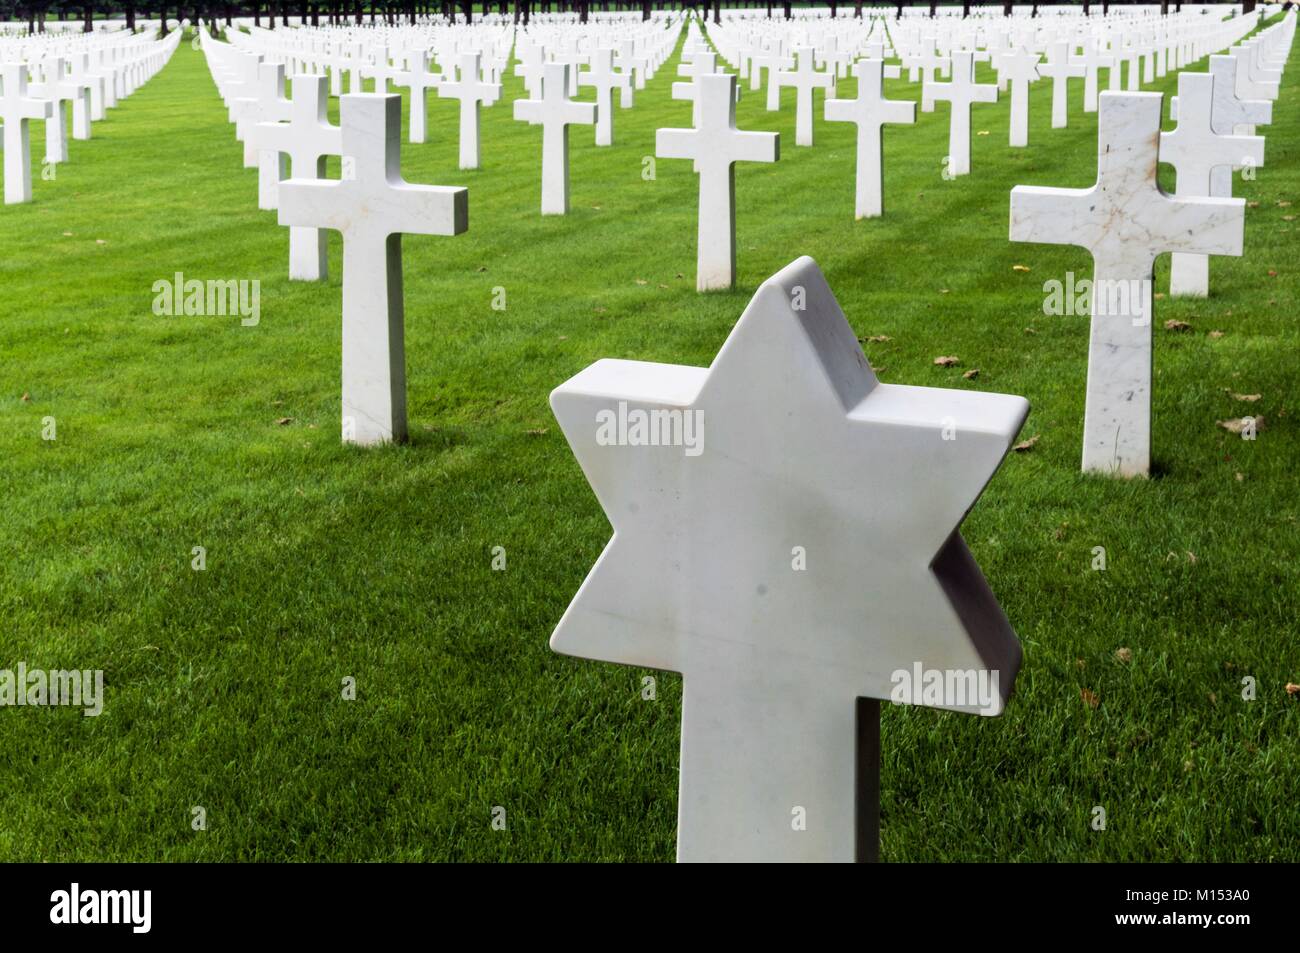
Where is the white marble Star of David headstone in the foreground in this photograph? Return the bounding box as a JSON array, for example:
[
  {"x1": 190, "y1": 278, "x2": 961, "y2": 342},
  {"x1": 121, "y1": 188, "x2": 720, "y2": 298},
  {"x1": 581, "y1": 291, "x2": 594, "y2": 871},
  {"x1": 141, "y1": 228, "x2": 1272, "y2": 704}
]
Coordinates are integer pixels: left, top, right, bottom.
[{"x1": 550, "y1": 254, "x2": 1028, "y2": 862}]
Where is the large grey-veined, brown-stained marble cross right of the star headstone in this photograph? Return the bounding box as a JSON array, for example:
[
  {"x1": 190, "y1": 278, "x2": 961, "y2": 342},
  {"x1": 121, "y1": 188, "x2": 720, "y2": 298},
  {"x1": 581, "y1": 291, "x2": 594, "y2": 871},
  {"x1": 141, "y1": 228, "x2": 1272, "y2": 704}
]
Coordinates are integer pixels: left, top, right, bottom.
[{"x1": 1010, "y1": 91, "x2": 1245, "y2": 476}]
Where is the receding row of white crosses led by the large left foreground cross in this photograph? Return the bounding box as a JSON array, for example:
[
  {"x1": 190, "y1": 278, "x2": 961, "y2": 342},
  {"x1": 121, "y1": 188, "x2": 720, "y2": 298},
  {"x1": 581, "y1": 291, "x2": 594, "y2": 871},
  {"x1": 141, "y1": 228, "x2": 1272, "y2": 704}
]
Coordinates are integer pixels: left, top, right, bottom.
[{"x1": 203, "y1": 26, "x2": 488, "y2": 445}]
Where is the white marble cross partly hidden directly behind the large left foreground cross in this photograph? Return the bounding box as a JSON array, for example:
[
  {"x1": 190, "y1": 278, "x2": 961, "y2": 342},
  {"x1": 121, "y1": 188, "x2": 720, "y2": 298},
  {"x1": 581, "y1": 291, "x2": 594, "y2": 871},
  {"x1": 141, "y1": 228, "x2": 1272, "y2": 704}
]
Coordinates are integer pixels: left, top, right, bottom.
[{"x1": 251, "y1": 74, "x2": 343, "y2": 281}]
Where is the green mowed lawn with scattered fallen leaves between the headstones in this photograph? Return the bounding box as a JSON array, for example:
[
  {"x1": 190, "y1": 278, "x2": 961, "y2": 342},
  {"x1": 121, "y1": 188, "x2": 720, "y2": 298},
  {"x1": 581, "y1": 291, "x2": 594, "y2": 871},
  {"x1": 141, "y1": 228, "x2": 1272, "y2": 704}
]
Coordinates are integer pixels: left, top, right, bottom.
[{"x1": 0, "y1": 18, "x2": 1300, "y2": 861}]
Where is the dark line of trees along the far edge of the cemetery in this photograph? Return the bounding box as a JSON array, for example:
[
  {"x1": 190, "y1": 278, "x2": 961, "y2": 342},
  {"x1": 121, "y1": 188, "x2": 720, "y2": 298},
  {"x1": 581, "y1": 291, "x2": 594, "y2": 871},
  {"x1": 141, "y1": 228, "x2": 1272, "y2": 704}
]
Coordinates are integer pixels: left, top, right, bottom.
[{"x1": 0, "y1": 0, "x2": 1255, "y2": 33}]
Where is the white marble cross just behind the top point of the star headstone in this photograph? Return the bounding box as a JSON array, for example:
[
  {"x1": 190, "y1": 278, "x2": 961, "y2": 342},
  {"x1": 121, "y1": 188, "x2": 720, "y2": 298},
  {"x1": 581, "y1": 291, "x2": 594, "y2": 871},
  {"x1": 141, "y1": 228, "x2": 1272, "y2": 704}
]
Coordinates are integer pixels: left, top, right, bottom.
[{"x1": 655, "y1": 73, "x2": 780, "y2": 291}]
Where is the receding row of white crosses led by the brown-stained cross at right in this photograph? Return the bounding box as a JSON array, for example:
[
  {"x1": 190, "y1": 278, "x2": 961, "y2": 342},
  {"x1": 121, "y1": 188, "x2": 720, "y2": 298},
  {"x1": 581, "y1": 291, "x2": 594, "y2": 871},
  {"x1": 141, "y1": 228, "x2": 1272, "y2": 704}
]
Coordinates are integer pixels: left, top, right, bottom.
[{"x1": 1010, "y1": 8, "x2": 1295, "y2": 476}]
